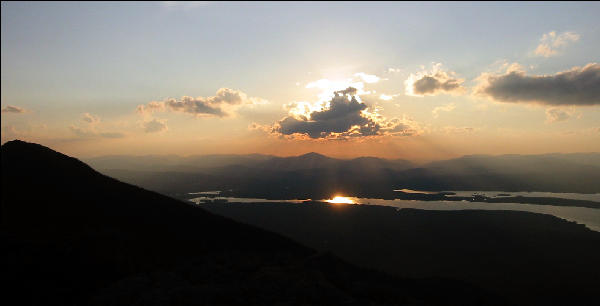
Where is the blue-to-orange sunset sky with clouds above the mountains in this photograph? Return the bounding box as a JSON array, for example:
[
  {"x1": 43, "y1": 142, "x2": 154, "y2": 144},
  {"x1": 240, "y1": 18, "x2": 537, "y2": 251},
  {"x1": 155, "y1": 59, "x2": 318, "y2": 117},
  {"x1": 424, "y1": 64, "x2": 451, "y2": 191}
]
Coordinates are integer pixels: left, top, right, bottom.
[{"x1": 1, "y1": 2, "x2": 600, "y2": 161}]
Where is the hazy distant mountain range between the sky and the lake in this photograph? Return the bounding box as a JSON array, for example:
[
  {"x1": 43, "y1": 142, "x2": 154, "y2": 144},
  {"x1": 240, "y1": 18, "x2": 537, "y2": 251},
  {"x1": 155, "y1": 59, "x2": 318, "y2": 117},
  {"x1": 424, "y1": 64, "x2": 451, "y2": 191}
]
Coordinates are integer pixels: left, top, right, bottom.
[{"x1": 87, "y1": 153, "x2": 600, "y2": 199}]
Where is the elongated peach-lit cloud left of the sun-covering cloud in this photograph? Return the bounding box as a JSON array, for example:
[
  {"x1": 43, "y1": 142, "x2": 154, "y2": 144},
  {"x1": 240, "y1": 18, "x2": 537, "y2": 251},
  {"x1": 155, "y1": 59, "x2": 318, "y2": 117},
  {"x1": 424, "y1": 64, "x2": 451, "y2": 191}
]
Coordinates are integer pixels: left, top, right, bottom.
[{"x1": 137, "y1": 88, "x2": 267, "y2": 117}]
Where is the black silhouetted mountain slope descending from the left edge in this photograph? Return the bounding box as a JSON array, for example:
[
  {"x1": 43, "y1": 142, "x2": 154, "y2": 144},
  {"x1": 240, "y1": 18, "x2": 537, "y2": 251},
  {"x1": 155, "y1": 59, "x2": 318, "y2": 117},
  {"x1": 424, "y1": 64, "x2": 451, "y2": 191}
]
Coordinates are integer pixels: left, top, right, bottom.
[{"x1": 0, "y1": 141, "x2": 502, "y2": 305}]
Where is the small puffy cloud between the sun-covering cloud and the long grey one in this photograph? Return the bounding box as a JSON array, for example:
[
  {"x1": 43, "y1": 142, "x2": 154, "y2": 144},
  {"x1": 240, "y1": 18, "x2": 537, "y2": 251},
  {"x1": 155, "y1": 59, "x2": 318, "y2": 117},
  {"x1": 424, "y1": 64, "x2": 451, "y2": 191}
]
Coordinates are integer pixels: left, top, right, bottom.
[{"x1": 404, "y1": 63, "x2": 465, "y2": 97}]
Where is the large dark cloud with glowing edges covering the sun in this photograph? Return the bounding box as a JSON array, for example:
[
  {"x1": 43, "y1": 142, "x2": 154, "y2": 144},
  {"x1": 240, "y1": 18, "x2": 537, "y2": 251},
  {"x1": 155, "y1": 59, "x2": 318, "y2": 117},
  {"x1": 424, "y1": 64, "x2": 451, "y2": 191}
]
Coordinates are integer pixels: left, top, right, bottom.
[{"x1": 274, "y1": 87, "x2": 416, "y2": 139}]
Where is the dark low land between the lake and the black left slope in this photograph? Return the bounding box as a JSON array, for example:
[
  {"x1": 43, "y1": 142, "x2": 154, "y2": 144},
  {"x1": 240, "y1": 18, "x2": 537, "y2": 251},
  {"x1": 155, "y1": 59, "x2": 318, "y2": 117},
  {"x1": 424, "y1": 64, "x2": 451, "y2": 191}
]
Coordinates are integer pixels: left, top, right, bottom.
[{"x1": 202, "y1": 202, "x2": 600, "y2": 305}]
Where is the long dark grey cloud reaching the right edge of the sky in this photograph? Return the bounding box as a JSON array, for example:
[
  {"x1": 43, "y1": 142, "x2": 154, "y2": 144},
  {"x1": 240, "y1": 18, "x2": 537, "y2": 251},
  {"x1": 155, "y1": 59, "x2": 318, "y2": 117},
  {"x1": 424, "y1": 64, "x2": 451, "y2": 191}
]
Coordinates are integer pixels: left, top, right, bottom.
[{"x1": 475, "y1": 63, "x2": 600, "y2": 105}]
